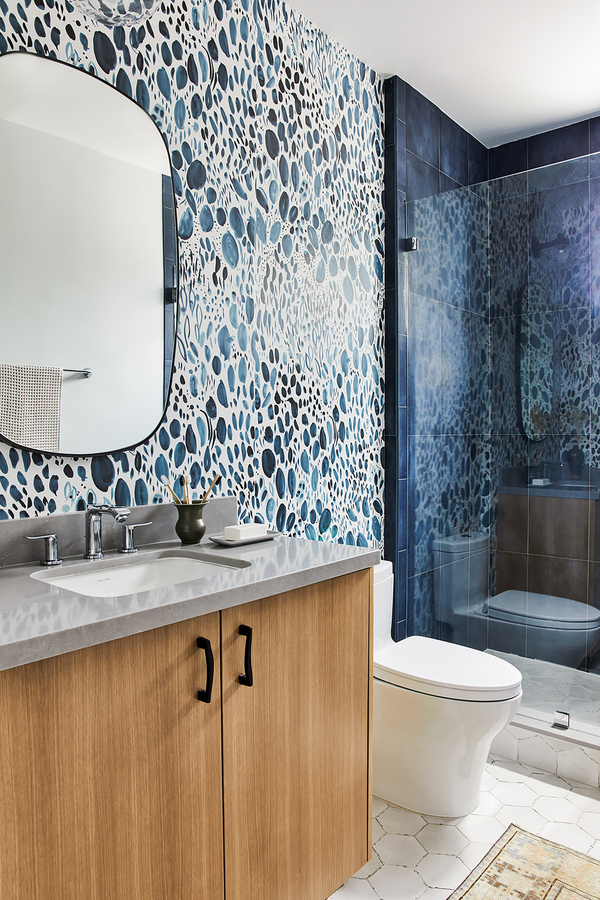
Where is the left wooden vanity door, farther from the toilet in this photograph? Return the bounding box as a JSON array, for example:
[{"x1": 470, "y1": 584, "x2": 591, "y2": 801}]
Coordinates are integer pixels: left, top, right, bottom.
[{"x1": 0, "y1": 601, "x2": 223, "y2": 900}]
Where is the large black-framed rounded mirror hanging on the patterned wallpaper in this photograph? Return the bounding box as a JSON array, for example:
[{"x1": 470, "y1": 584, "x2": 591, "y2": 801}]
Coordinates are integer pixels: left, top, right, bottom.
[{"x1": 0, "y1": 53, "x2": 177, "y2": 456}]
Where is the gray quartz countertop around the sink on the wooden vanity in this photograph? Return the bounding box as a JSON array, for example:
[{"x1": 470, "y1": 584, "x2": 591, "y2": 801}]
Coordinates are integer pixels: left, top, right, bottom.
[{"x1": 0, "y1": 536, "x2": 380, "y2": 670}]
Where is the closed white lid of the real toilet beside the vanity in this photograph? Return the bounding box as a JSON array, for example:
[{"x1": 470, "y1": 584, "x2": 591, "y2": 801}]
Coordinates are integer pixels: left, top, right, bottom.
[{"x1": 373, "y1": 637, "x2": 521, "y2": 701}]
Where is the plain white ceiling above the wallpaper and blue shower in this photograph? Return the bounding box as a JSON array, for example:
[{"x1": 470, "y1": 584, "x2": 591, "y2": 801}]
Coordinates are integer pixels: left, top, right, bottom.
[{"x1": 289, "y1": 0, "x2": 600, "y2": 147}]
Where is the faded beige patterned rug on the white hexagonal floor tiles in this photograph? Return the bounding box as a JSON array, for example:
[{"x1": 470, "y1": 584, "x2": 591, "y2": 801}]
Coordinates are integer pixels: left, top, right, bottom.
[{"x1": 449, "y1": 825, "x2": 600, "y2": 900}]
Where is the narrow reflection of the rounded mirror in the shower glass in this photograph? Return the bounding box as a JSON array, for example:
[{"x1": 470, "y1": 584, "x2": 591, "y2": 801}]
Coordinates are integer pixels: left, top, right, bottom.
[{"x1": 516, "y1": 284, "x2": 554, "y2": 441}]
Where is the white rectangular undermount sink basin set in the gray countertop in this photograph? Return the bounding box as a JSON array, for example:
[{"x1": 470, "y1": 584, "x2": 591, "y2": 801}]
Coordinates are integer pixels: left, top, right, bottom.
[{"x1": 31, "y1": 551, "x2": 252, "y2": 597}]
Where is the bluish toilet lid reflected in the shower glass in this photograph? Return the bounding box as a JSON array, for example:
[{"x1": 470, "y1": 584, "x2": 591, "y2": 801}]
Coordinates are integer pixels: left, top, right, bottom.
[{"x1": 487, "y1": 591, "x2": 600, "y2": 631}]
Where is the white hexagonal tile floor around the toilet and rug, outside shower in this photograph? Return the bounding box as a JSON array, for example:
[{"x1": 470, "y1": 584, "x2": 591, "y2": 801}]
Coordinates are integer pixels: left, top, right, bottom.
[{"x1": 333, "y1": 758, "x2": 600, "y2": 900}]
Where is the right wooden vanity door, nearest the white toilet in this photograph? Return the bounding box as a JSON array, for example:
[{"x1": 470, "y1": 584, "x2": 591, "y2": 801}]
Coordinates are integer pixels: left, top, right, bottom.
[{"x1": 221, "y1": 571, "x2": 372, "y2": 900}]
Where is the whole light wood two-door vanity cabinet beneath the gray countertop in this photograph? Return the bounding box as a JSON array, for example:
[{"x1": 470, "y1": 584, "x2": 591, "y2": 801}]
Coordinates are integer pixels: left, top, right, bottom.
[{"x1": 0, "y1": 570, "x2": 372, "y2": 900}]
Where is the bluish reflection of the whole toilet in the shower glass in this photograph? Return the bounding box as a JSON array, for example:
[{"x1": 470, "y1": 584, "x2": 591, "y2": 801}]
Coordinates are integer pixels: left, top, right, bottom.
[{"x1": 433, "y1": 534, "x2": 600, "y2": 668}]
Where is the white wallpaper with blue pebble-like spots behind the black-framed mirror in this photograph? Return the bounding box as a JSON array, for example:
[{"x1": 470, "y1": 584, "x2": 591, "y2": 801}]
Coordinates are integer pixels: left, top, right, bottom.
[{"x1": 0, "y1": 0, "x2": 384, "y2": 545}]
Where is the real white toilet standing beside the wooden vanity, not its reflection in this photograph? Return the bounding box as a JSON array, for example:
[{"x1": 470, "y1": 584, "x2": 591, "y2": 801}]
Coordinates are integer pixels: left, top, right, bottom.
[{"x1": 373, "y1": 560, "x2": 521, "y2": 818}]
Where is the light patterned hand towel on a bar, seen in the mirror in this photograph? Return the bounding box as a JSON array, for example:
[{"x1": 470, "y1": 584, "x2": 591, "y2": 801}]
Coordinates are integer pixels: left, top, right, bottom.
[{"x1": 0, "y1": 363, "x2": 62, "y2": 451}]
